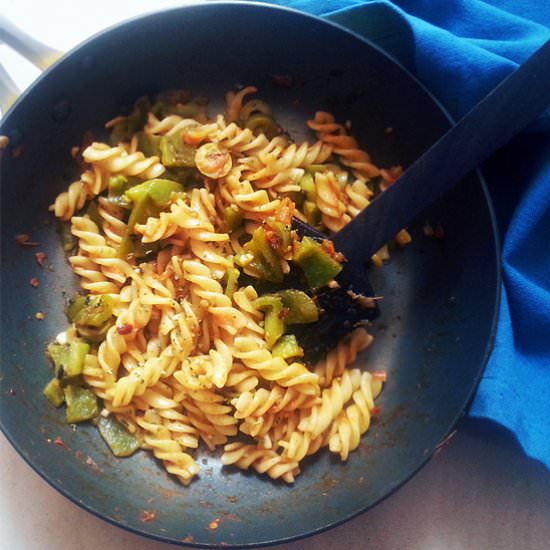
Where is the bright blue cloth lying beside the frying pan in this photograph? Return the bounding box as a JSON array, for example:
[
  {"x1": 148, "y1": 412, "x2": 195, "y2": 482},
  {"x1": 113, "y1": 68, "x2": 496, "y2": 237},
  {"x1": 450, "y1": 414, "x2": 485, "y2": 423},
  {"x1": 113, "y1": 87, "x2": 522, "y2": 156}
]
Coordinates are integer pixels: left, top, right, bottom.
[{"x1": 262, "y1": 0, "x2": 550, "y2": 468}]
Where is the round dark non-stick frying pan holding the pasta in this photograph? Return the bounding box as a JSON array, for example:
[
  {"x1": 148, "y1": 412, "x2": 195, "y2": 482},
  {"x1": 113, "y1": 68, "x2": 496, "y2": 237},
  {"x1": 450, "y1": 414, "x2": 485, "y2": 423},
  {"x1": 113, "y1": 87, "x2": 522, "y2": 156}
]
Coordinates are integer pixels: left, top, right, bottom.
[{"x1": 0, "y1": 3, "x2": 499, "y2": 546}]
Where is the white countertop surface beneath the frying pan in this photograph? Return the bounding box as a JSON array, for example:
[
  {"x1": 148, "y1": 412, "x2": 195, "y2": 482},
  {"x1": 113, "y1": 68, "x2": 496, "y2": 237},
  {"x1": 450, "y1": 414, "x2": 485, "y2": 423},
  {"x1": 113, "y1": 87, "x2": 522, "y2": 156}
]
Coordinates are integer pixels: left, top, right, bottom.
[{"x1": 0, "y1": 0, "x2": 550, "y2": 550}]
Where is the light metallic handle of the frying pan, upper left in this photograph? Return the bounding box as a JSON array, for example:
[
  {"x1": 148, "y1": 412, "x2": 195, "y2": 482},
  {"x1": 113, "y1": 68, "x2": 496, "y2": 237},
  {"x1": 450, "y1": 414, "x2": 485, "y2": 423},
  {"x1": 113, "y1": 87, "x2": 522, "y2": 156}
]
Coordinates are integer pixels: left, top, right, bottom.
[{"x1": 0, "y1": 15, "x2": 63, "y2": 114}]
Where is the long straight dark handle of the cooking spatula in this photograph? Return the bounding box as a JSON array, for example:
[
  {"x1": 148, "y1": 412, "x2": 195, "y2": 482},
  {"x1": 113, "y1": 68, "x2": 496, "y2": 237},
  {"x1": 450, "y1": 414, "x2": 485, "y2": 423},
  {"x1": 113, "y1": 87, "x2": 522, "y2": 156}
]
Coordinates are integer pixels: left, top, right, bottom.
[{"x1": 332, "y1": 40, "x2": 550, "y2": 267}]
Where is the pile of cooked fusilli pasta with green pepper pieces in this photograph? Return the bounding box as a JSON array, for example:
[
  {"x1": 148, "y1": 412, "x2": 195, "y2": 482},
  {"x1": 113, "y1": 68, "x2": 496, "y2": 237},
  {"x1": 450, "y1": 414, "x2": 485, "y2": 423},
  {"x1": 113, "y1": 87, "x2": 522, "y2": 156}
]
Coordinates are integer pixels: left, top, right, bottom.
[{"x1": 44, "y1": 87, "x2": 409, "y2": 484}]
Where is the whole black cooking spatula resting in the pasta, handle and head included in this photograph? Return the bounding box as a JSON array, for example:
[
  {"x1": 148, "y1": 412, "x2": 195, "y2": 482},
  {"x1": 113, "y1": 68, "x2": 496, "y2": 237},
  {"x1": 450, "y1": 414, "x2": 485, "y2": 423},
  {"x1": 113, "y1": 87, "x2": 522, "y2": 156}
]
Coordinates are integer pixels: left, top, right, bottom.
[{"x1": 293, "y1": 36, "x2": 550, "y2": 361}]
